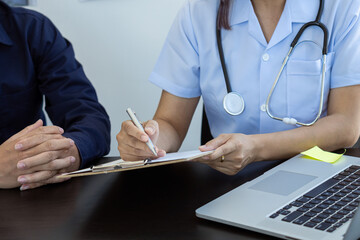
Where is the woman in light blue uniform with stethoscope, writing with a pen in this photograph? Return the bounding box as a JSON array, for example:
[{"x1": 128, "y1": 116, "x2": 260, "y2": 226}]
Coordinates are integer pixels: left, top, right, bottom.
[{"x1": 117, "y1": 0, "x2": 360, "y2": 175}]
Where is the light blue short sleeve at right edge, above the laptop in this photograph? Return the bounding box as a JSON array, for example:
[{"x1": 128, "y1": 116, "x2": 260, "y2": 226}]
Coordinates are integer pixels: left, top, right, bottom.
[{"x1": 330, "y1": 1, "x2": 360, "y2": 88}]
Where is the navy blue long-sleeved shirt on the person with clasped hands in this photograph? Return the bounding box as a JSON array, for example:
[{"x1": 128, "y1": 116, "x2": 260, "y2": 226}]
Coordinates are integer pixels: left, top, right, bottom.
[{"x1": 0, "y1": 1, "x2": 110, "y2": 167}]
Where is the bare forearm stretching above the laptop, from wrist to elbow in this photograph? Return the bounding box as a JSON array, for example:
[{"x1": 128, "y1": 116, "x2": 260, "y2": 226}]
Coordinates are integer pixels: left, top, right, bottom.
[{"x1": 252, "y1": 114, "x2": 359, "y2": 161}]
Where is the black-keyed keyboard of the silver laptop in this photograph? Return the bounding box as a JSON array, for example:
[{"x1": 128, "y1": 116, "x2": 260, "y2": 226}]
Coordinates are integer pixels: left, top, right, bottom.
[{"x1": 270, "y1": 165, "x2": 360, "y2": 232}]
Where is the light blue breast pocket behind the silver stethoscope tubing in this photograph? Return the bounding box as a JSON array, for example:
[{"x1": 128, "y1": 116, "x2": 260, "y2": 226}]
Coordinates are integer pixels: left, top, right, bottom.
[{"x1": 286, "y1": 53, "x2": 333, "y2": 123}]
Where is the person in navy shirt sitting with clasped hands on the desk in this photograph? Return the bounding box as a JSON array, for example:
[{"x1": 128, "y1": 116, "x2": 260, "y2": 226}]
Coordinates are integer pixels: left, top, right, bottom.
[{"x1": 0, "y1": 1, "x2": 110, "y2": 190}]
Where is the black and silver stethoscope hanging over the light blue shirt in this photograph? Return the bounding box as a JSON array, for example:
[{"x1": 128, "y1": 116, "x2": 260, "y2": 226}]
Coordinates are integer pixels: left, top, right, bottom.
[{"x1": 216, "y1": 0, "x2": 328, "y2": 126}]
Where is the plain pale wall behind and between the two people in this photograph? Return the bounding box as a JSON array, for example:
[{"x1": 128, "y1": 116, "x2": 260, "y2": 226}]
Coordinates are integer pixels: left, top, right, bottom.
[{"x1": 26, "y1": 0, "x2": 201, "y2": 156}]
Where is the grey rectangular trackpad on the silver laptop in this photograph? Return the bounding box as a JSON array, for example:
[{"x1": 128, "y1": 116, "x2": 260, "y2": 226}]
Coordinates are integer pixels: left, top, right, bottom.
[{"x1": 249, "y1": 170, "x2": 317, "y2": 196}]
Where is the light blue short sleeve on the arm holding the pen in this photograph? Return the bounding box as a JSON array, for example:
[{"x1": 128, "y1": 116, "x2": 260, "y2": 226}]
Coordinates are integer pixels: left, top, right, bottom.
[{"x1": 149, "y1": 1, "x2": 201, "y2": 98}]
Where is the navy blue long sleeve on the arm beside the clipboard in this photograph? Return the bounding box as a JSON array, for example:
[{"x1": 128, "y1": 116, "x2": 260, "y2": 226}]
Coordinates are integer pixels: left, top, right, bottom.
[{"x1": 31, "y1": 18, "x2": 110, "y2": 168}]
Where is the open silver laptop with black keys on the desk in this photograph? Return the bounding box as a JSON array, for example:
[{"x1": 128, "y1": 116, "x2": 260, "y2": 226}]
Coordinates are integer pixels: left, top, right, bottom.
[{"x1": 196, "y1": 155, "x2": 360, "y2": 240}]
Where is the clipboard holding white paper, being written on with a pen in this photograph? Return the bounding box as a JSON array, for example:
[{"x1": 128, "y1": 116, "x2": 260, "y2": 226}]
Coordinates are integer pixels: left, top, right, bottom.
[{"x1": 57, "y1": 150, "x2": 214, "y2": 178}]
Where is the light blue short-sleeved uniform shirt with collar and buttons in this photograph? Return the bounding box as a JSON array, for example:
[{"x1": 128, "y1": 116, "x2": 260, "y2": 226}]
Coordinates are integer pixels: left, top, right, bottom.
[{"x1": 150, "y1": 0, "x2": 360, "y2": 137}]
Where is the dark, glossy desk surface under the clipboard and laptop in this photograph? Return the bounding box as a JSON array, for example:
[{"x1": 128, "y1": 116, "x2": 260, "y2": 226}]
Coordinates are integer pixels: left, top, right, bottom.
[{"x1": 0, "y1": 149, "x2": 360, "y2": 240}]
